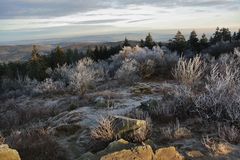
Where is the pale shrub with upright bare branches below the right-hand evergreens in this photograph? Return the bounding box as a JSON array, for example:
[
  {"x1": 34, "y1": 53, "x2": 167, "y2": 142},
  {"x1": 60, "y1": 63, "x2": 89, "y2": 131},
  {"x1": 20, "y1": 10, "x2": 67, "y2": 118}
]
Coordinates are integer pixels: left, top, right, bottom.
[{"x1": 172, "y1": 56, "x2": 205, "y2": 86}]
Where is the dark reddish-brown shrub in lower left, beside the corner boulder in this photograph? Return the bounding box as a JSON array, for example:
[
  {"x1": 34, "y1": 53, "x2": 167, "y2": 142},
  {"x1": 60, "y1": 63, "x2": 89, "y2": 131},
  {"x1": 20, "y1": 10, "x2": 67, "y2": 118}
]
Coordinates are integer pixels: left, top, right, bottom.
[{"x1": 7, "y1": 128, "x2": 67, "y2": 160}]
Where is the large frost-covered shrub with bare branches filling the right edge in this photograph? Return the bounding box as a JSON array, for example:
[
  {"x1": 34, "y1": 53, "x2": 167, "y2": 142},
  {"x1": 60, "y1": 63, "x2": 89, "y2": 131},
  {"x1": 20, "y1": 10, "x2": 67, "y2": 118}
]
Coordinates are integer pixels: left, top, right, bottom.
[{"x1": 194, "y1": 51, "x2": 240, "y2": 122}]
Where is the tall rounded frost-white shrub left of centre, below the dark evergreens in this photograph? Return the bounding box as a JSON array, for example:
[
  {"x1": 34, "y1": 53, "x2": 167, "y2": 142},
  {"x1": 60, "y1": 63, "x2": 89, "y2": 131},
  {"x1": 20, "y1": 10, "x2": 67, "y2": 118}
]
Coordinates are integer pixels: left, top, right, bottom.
[{"x1": 70, "y1": 58, "x2": 97, "y2": 95}]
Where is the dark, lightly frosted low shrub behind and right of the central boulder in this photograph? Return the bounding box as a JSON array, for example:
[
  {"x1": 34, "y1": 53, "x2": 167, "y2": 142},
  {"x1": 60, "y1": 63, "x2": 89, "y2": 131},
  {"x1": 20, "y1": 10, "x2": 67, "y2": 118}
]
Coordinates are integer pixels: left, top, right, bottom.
[{"x1": 140, "y1": 85, "x2": 194, "y2": 119}]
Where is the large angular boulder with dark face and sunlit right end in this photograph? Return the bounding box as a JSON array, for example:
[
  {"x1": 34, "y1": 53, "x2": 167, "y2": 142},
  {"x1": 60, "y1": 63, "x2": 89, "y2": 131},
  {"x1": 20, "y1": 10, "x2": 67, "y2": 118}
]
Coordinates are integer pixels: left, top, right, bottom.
[{"x1": 113, "y1": 116, "x2": 148, "y2": 140}]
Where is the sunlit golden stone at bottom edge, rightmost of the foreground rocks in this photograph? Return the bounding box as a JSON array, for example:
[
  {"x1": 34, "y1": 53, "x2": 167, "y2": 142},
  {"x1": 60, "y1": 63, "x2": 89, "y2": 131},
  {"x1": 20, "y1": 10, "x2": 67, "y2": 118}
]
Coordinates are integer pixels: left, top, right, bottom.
[{"x1": 155, "y1": 147, "x2": 184, "y2": 160}]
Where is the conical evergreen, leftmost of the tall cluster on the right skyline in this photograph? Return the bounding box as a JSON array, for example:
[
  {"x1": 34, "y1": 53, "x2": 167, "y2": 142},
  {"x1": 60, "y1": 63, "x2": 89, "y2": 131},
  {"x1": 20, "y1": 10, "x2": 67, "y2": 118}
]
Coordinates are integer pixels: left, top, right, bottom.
[{"x1": 173, "y1": 31, "x2": 187, "y2": 54}]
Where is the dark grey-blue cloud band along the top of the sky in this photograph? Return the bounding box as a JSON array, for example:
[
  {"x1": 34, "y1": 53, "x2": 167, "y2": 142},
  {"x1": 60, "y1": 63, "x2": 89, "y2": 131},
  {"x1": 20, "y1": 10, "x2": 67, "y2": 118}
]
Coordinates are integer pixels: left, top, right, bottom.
[{"x1": 0, "y1": 0, "x2": 240, "y2": 19}]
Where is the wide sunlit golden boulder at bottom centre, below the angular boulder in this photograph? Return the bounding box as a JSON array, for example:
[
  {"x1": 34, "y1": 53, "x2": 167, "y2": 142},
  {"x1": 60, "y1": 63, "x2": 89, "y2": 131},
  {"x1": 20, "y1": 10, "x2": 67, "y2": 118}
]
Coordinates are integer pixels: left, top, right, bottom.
[{"x1": 100, "y1": 145, "x2": 154, "y2": 160}]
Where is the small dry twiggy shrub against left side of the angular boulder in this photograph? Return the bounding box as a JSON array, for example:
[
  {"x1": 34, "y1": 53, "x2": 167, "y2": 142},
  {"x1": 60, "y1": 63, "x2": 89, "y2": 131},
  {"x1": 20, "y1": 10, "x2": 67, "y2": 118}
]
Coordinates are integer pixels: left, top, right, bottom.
[{"x1": 91, "y1": 117, "x2": 115, "y2": 142}]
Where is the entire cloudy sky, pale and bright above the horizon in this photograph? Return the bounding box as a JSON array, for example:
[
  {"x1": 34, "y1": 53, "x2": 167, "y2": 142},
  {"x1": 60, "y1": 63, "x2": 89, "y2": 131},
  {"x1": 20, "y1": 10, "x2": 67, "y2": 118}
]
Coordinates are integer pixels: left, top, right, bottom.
[{"x1": 0, "y1": 0, "x2": 240, "y2": 43}]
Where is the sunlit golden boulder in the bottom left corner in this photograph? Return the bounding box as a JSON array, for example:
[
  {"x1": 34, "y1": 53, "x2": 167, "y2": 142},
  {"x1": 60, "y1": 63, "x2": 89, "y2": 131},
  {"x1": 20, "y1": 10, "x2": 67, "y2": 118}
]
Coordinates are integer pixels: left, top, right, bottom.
[{"x1": 0, "y1": 144, "x2": 21, "y2": 160}]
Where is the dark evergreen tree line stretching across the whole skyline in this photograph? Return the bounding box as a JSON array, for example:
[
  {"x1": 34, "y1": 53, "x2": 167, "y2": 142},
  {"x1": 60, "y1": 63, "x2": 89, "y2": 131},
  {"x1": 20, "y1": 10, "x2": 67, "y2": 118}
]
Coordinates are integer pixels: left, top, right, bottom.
[{"x1": 0, "y1": 27, "x2": 240, "y2": 81}]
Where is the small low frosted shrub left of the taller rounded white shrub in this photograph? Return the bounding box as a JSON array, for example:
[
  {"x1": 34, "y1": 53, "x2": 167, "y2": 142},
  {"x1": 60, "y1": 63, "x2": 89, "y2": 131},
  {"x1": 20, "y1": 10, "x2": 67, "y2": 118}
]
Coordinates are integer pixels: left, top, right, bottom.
[{"x1": 34, "y1": 78, "x2": 65, "y2": 93}]
